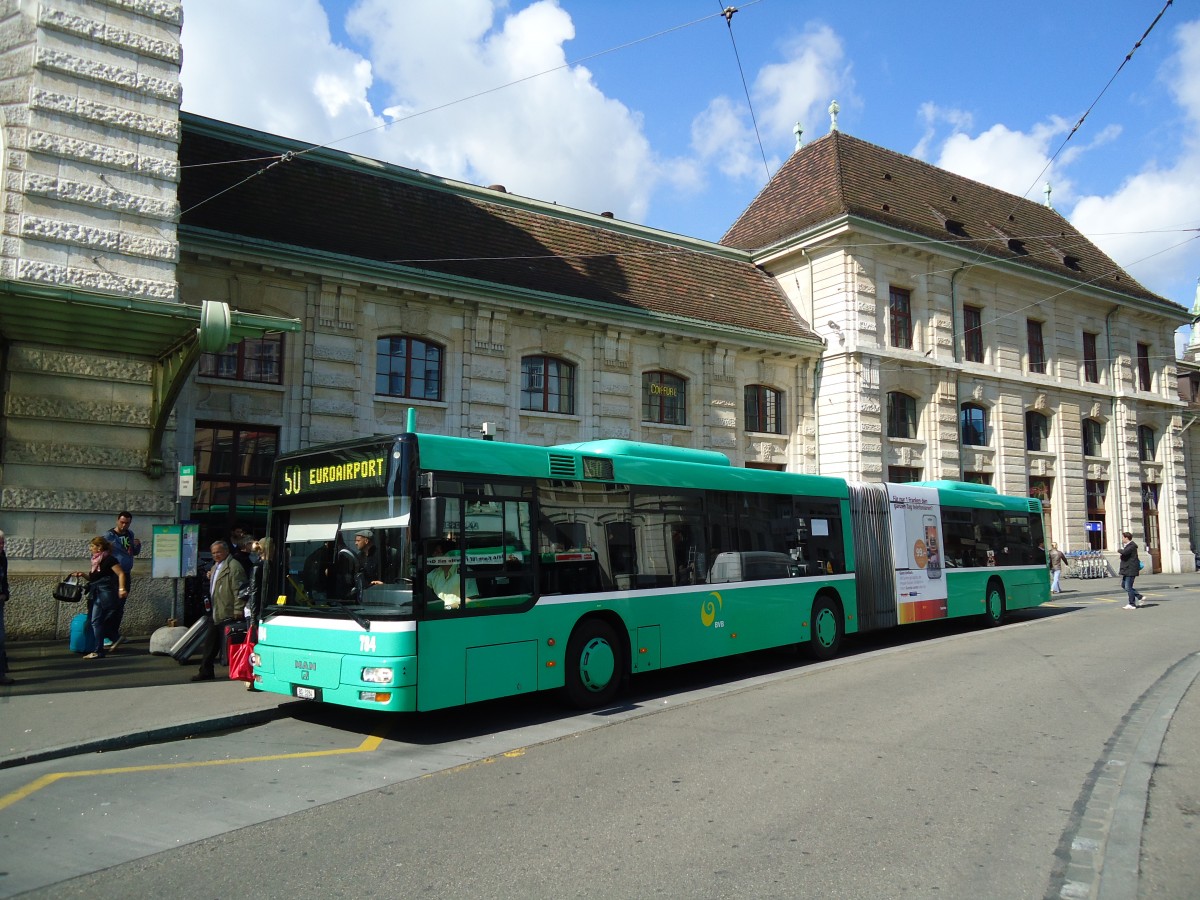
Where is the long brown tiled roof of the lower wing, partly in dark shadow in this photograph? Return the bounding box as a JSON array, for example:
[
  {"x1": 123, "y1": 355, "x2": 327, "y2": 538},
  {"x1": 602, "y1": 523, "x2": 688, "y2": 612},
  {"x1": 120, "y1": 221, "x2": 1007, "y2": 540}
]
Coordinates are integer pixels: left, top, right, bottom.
[{"x1": 179, "y1": 115, "x2": 820, "y2": 341}]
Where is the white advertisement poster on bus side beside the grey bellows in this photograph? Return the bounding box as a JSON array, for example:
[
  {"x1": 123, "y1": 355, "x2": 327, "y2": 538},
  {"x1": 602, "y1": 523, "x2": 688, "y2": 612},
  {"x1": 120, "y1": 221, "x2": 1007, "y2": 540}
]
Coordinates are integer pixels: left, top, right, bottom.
[{"x1": 888, "y1": 485, "x2": 947, "y2": 625}]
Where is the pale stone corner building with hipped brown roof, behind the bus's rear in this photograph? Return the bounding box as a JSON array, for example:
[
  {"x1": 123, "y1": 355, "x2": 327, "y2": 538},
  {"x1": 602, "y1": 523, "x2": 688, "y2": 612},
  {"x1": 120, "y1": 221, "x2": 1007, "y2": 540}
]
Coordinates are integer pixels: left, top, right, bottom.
[{"x1": 722, "y1": 131, "x2": 1194, "y2": 571}]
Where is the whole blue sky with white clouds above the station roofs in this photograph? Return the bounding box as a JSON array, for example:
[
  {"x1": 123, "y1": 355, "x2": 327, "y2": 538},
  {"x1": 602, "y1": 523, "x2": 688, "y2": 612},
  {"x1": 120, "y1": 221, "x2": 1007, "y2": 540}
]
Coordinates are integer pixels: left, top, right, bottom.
[{"x1": 182, "y1": 0, "x2": 1200, "y2": 324}]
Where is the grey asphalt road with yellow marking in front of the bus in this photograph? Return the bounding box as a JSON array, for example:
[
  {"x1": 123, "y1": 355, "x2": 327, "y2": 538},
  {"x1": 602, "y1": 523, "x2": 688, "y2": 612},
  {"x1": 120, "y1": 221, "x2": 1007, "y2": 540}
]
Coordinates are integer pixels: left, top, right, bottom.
[{"x1": 0, "y1": 590, "x2": 1200, "y2": 899}]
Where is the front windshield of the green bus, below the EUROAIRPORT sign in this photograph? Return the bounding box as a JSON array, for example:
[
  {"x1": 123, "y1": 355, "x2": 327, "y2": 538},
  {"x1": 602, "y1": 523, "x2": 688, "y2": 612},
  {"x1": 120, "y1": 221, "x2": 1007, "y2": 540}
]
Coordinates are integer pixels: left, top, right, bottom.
[{"x1": 277, "y1": 498, "x2": 413, "y2": 617}]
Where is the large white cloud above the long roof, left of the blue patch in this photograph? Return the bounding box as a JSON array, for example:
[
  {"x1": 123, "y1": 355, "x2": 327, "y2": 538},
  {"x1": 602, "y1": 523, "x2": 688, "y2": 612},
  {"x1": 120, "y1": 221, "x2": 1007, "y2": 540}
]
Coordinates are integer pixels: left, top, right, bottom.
[{"x1": 184, "y1": 0, "x2": 667, "y2": 221}]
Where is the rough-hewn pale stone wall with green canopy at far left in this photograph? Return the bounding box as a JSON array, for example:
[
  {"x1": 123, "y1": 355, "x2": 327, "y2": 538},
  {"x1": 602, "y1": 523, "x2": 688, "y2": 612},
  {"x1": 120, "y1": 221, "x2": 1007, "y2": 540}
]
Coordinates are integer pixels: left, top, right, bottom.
[{"x1": 0, "y1": 0, "x2": 293, "y2": 638}]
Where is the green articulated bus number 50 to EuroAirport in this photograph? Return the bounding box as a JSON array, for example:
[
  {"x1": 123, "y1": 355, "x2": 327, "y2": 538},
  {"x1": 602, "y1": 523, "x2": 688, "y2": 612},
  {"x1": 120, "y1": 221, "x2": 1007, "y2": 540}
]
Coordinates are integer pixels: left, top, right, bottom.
[{"x1": 253, "y1": 420, "x2": 1050, "y2": 712}]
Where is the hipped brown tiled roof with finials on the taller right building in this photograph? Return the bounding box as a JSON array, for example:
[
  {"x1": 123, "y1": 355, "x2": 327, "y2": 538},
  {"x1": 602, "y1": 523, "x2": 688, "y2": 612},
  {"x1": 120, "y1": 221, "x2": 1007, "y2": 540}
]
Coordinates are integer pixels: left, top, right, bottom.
[{"x1": 721, "y1": 131, "x2": 1176, "y2": 306}]
